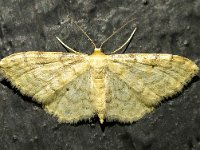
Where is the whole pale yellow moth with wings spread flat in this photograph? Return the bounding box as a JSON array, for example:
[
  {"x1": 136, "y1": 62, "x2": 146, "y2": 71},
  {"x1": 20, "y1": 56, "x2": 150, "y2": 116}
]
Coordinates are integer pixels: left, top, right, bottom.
[{"x1": 0, "y1": 21, "x2": 199, "y2": 124}]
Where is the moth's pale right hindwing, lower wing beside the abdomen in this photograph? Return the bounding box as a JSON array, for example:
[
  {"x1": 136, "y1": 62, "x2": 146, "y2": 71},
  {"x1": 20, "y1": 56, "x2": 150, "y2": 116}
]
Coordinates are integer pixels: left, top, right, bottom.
[{"x1": 105, "y1": 71, "x2": 153, "y2": 123}]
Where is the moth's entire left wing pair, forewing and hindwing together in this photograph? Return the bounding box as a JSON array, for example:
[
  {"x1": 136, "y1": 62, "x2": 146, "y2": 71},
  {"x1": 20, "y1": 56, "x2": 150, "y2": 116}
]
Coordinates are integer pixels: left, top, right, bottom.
[{"x1": 0, "y1": 51, "x2": 94, "y2": 123}]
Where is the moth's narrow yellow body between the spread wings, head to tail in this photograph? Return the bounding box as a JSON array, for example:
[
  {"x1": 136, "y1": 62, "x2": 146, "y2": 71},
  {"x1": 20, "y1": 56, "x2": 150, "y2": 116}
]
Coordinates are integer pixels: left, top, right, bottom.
[{"x1": 88, "y1": 49, "x2": 107, "y2": 123}]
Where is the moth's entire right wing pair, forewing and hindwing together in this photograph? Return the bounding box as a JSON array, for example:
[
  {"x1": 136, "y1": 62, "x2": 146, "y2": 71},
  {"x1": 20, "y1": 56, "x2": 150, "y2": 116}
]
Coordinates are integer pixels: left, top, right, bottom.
[{"x1": 106, "y1": 53, "x2": 198, "y2": 122}]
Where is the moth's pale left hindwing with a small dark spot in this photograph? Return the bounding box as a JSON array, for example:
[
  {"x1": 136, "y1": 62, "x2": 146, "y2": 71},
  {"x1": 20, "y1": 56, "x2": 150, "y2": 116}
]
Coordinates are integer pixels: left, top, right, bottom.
[{"x1": 45, "y1": 71, "x2": 95, "y2": 123}]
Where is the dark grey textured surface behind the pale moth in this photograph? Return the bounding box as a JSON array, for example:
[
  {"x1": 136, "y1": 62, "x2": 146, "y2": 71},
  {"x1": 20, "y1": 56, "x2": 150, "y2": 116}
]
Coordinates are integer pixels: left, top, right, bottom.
[{"x1": 0, "y1": 0, "x2": 200, "y2": 150}]
